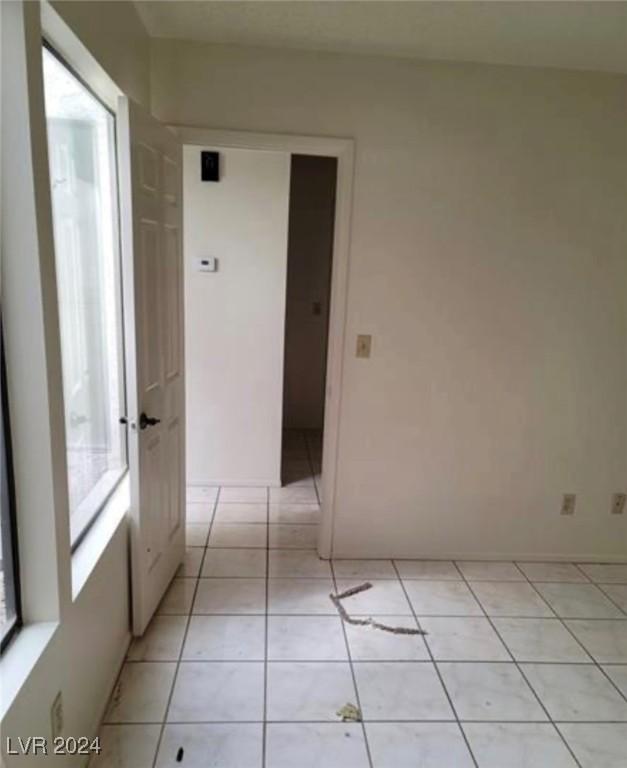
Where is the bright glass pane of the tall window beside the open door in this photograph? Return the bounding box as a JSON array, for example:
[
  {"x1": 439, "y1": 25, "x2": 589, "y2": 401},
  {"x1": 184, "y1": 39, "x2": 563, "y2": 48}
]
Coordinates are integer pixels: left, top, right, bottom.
[{"x1": 43, "y1": 49, "x2": 126, "y2": 543}]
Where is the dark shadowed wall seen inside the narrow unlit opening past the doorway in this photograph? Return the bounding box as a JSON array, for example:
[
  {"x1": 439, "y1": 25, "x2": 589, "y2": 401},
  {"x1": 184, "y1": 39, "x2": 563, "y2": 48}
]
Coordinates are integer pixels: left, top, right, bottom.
[{"x1": 283, "y1": 155, "x2": 337, "y2": 429}]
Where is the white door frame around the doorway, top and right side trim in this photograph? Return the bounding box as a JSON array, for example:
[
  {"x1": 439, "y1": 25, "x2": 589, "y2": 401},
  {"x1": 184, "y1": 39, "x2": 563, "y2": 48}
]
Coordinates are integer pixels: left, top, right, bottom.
[{"x1": 177, "y1": 125, "x2": 355, "y2": 558}]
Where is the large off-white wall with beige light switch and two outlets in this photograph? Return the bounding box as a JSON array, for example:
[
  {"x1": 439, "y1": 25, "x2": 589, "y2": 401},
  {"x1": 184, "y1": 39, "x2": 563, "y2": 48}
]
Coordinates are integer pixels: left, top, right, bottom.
[{"x1": 152, "y1": 40, "x2": 627, "y2": 558}]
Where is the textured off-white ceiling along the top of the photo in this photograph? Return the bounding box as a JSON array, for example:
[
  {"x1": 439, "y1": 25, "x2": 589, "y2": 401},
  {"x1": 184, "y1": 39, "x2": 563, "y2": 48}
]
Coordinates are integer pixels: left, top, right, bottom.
[{"x1": 135, "y1": 0, "x2": 627, "y2": 73}]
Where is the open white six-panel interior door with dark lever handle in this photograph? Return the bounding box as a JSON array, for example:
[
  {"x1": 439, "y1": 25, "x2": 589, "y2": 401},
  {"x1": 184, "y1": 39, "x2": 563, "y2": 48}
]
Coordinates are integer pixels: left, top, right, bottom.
[{"x1": 118, "y1": 98, "x2": 185, "y2": 635}]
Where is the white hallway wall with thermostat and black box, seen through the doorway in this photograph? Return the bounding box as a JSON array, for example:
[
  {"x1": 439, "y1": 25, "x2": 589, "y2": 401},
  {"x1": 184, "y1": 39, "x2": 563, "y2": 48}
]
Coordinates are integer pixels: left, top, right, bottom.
[{"x1": 183, "y1": 146, "x2": 290, "y2": 485}]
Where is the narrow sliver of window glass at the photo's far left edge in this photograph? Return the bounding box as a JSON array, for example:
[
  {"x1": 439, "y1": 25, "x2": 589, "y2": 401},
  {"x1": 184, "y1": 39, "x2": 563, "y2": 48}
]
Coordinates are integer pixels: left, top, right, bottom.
[{"x1": 0, "y1": 334, "x2": 19, "y2": 645}]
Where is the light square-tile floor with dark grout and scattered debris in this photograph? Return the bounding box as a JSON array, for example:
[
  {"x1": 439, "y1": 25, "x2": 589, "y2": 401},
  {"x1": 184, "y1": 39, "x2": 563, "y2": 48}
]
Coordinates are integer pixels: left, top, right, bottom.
[{"x1": 92, "y1": 428, "x2": 627, "y2": 768}]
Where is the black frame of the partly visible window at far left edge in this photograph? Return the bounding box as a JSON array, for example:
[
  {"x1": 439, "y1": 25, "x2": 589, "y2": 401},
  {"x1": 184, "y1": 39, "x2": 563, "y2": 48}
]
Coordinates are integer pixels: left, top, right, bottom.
[{"x1": 0, "y1": 320, "x2": 23, "y2": 654}]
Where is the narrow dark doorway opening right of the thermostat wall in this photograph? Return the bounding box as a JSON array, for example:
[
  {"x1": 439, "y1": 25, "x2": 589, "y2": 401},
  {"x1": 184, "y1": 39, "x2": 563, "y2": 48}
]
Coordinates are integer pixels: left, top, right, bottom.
[{"x1": 281, "y1": 154, "x2": 337, "y2": 503}]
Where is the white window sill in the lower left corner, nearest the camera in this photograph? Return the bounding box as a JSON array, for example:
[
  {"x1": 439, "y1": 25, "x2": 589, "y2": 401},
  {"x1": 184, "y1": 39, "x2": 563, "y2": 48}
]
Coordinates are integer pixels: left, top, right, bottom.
[{"x1": 0, "y1": 621, "x2": 60, "y2": 721}]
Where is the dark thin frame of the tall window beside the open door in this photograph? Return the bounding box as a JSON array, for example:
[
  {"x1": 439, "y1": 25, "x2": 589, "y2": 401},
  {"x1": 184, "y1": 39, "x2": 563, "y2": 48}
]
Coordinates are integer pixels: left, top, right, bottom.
[{"x1": 41, "y1": 40, "x2": 129, "y2": 555}]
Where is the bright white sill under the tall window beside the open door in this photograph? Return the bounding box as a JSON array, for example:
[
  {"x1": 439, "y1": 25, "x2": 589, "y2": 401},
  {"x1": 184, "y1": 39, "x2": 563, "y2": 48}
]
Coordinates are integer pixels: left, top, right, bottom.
[{"x1": 72, "y1": 473, "x2": 131, "y2": 600}]
